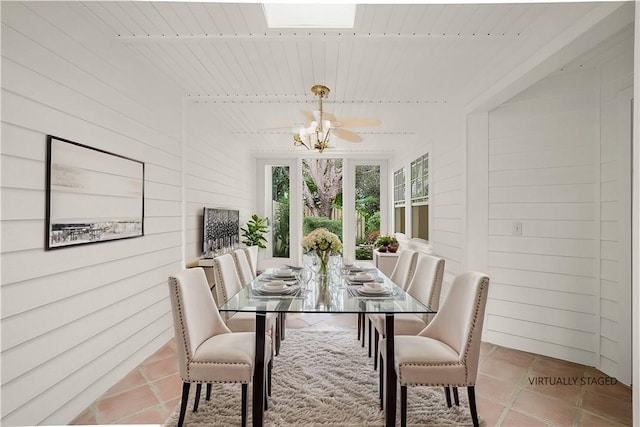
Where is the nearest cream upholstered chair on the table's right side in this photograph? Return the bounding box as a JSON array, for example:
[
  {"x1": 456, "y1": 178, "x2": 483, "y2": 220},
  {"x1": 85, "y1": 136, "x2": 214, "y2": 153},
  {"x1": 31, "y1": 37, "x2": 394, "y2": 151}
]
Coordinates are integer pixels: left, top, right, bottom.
[{"x1": 380, "y1": 272, "x2": 489, "y2": 427}]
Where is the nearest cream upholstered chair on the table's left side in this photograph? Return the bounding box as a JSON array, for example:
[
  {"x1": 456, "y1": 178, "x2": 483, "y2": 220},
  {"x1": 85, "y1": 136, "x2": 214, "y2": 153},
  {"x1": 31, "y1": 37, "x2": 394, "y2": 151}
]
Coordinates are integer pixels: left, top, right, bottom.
[{"x1": 169, "y1": 267, "x2": 272, "y2": 427}]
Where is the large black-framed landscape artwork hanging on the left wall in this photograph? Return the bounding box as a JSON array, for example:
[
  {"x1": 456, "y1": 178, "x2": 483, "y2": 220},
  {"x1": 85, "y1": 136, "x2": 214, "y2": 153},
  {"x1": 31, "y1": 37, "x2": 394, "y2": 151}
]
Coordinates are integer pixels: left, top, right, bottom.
[{"x1": 46, "y1": 135, "x2": 144, "y2": 249}]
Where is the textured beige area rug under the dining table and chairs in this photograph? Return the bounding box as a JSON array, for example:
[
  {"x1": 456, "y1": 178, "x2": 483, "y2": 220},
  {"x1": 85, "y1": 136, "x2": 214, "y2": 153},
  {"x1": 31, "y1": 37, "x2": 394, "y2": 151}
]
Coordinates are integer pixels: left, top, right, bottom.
[{"x1": 164, "y1": 329, "x2": 484, "y2": 427}]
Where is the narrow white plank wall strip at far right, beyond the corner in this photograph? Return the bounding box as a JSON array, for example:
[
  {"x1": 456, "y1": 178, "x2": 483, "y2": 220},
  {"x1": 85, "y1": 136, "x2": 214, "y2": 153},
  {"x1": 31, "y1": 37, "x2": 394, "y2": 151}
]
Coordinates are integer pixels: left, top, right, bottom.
[{"x1": 598, "y1": 31, "x2": 633, "y2": 382}]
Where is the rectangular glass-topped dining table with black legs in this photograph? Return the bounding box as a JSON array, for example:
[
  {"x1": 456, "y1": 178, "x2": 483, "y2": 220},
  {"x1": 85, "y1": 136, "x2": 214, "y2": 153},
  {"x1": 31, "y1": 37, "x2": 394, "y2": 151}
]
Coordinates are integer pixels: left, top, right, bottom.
[{"x1": 219, "y1": 265, "x2": 435, "y2": 426}]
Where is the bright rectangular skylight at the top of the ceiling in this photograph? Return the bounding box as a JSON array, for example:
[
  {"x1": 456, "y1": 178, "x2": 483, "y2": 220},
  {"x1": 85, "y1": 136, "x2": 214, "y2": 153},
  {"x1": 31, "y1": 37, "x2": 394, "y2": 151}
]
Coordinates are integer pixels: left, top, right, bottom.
[{"x1": 262, "y1": 3, "x2": 356, "y2": 28}]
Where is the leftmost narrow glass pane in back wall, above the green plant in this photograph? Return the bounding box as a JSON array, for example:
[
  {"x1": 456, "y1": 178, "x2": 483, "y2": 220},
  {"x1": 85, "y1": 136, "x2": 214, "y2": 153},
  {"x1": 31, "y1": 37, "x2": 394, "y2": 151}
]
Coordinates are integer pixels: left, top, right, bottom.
[{"x1": 271, "y1": 166, "x2": 291, "y2": 258}]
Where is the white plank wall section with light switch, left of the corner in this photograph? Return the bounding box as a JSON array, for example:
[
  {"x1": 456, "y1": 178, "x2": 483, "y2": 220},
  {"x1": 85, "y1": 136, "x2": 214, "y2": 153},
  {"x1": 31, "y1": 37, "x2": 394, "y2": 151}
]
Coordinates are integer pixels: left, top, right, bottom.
[{"x1": 484, "y1": 68, "x2": 599, "y2": 365}]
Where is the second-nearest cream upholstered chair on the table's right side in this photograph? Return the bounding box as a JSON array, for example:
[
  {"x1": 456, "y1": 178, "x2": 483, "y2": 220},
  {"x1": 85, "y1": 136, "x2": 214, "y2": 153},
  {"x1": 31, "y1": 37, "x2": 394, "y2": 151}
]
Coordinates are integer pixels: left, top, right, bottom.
[{"x1": 369, "y1": 253, "x2": 444, "y2": 369}]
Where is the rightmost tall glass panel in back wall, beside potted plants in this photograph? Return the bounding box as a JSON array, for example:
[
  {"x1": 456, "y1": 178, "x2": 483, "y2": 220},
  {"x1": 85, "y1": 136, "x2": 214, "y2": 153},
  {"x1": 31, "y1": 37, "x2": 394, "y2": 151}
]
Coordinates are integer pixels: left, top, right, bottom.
[{"x1": 354, "y1": 165, "x2": 380, "y2": 260}]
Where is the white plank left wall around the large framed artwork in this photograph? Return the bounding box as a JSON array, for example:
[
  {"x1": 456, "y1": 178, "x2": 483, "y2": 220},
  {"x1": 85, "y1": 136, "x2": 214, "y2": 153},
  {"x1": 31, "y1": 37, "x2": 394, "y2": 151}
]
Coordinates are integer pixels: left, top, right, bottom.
[{"x1": 0, "y1": 2, "x2": 181, "y2": 425}]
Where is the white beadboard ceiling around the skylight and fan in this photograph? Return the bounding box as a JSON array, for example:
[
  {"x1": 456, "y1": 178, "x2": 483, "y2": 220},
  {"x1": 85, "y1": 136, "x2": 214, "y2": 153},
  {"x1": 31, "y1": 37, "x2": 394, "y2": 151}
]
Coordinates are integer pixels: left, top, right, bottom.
[{"x1": 82, "y1": 1, "x2": 632, "y2": 151}]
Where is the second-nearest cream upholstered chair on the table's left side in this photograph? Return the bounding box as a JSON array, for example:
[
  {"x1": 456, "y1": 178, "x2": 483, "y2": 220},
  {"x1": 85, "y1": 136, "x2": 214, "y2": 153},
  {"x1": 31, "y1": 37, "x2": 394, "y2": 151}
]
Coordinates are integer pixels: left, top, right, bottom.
[{"x1": 213, "y1": 254, "x2": 280, "y2": 355}]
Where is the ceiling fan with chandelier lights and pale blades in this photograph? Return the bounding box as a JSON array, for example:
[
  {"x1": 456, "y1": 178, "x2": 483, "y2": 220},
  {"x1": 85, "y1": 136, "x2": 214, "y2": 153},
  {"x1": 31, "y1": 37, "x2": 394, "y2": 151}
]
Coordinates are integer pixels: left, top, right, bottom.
[{"x1": 292, "y1": 85, "x2": 382, "y2": 153}]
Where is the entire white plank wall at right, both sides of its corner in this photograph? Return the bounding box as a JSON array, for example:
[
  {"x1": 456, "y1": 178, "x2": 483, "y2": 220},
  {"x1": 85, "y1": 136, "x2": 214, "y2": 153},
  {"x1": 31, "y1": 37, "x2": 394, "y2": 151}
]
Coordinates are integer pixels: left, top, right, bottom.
[{"x1": 485, "y1": 29, "x2": 633, "y2": 372}]
